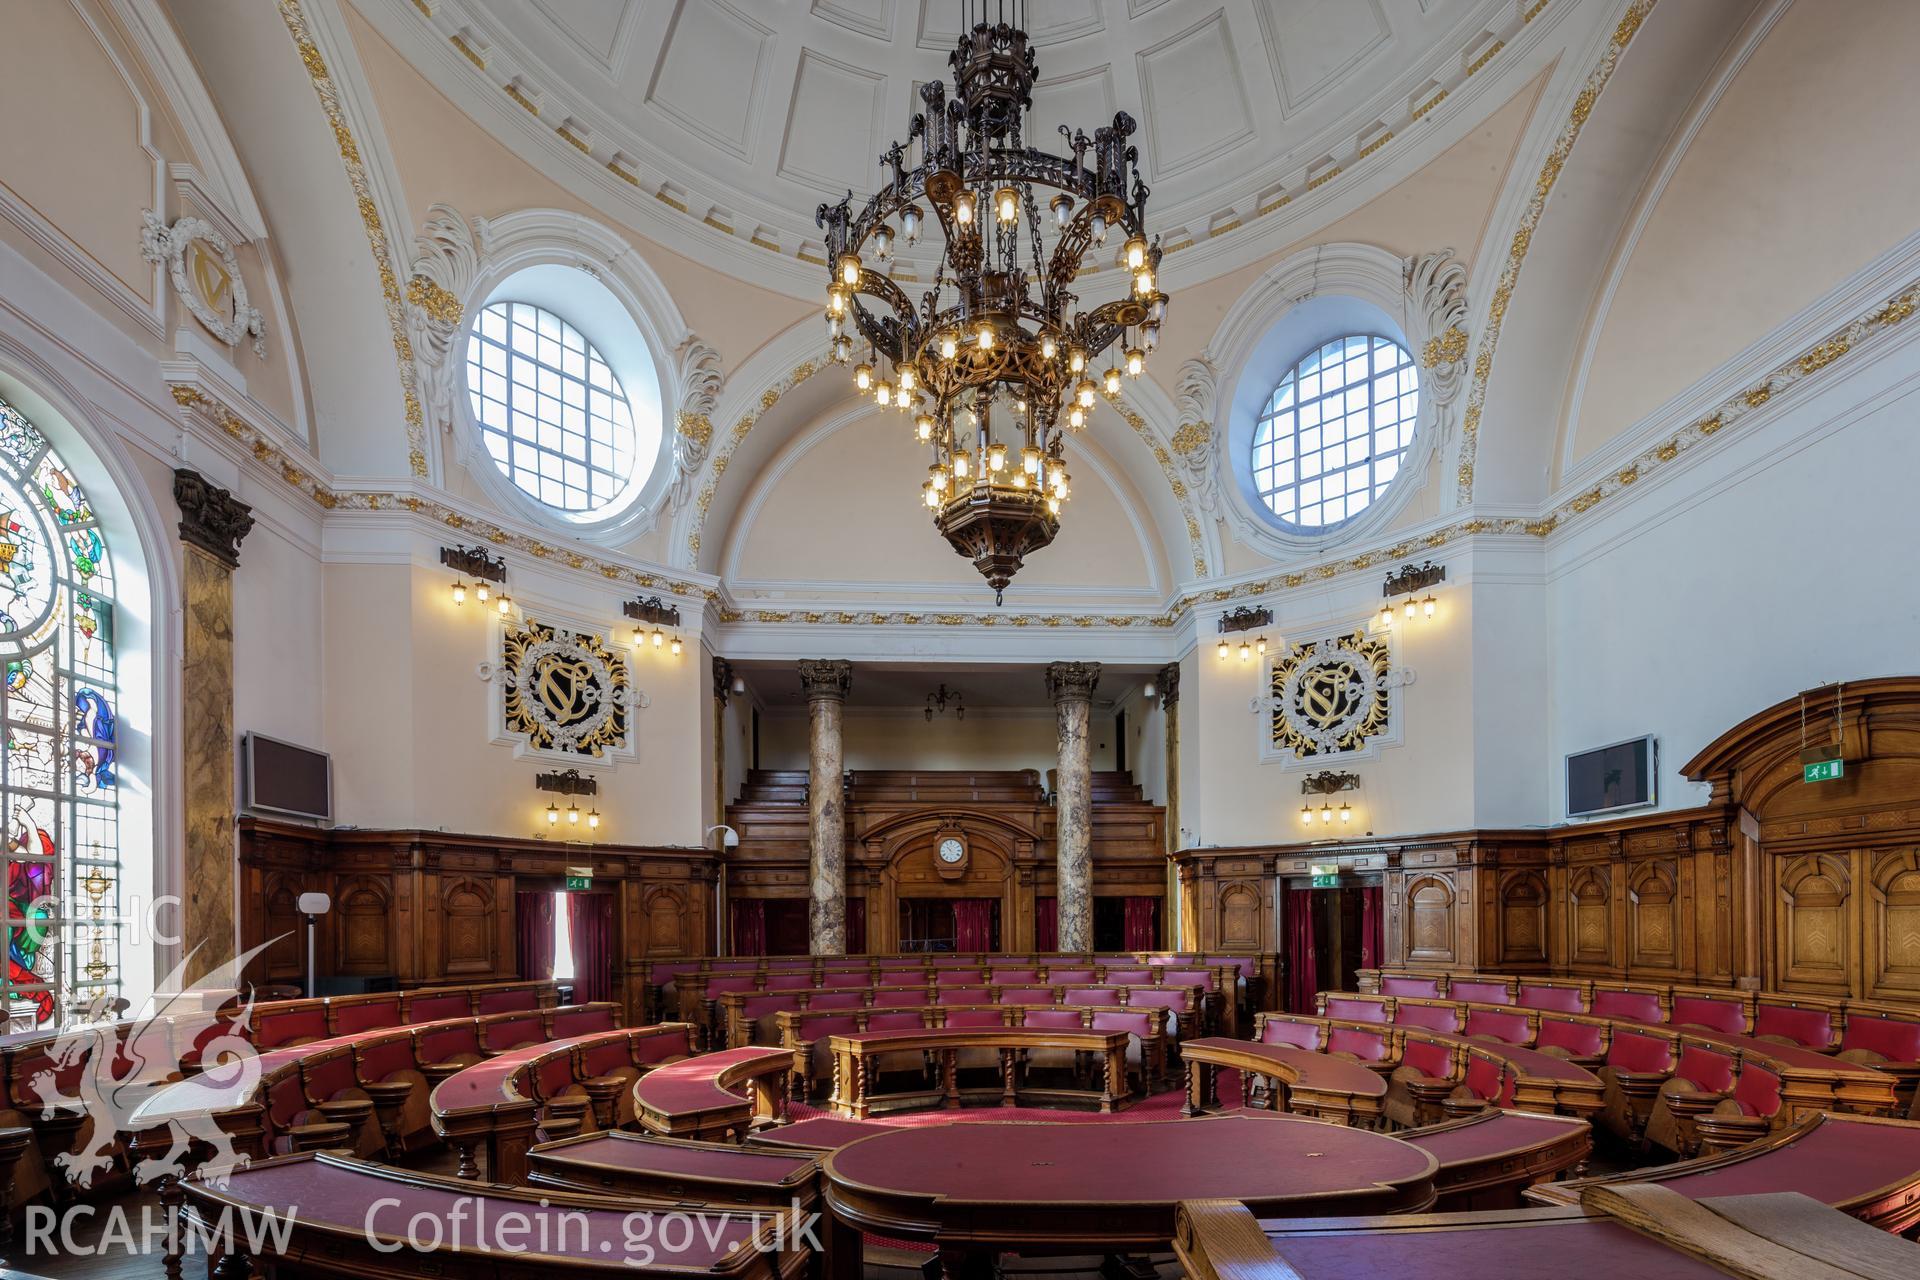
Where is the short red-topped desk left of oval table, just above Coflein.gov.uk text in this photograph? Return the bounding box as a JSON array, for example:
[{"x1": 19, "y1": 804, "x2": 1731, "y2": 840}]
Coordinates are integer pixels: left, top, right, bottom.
[{"x1": 526, "y1": 1130, "x2": 820, "y2": 1209}]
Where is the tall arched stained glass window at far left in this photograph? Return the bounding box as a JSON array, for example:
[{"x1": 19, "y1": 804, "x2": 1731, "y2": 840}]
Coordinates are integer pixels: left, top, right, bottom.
[{"x1": 0, "y1": 401, "x2": 121, "y2": 1031}]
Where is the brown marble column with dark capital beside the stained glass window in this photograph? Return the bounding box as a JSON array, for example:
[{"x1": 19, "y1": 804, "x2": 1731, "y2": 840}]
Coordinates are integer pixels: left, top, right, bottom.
[{"x1": 173, "y1": 475, "x2": 253, "y2": 981}]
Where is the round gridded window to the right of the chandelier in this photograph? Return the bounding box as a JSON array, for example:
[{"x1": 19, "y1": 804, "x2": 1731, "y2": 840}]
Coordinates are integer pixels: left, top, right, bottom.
[{"x1": 1252, "y1": 334, "x2": 1421, "y2": 530}]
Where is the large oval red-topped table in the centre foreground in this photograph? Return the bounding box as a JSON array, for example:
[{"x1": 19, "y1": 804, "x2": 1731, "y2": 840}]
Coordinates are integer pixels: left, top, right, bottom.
[{"x1": 824, "y1": 1115, "x2": 1438, "y2": 1280}]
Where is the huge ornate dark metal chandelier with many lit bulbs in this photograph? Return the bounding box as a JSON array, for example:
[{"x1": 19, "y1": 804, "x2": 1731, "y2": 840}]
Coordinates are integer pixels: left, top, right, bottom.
[{"x1": 814, "y1": 0, "x2": 1167, "y2": 603}]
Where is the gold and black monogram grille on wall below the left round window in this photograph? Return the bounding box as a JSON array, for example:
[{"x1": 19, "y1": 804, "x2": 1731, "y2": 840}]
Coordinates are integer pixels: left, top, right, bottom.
[{"x1": 499, "y1": 618, "x2": 634, "y2": 758}]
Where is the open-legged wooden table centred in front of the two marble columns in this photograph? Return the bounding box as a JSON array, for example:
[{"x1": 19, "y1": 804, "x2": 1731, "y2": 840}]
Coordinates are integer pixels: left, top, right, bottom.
[{"x1": 828, "y1": 1027, "x2": 1129, "y2": 1121}]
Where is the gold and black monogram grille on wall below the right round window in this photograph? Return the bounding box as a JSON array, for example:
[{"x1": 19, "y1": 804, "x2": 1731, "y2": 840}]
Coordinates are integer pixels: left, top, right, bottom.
[{"x1": 1265, "y1": 628, "x2": 1404, "y2": 764}]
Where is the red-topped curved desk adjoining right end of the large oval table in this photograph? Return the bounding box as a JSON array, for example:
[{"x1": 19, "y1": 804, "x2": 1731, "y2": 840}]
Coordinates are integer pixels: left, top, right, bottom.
[{"x1": 1394, "y1": 1107, "x2": 1594, "y2": 1209}]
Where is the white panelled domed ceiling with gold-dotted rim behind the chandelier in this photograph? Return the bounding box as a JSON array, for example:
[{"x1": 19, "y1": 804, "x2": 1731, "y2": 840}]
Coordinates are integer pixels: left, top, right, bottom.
[{"x1": 369, "y1": 0, "x2": 1574, "y2": 286}]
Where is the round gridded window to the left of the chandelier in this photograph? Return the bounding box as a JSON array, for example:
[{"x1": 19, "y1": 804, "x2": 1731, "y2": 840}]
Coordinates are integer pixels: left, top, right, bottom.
[{"x1": 467, "y1": 301, "x2": 636, "y2": 514}]
